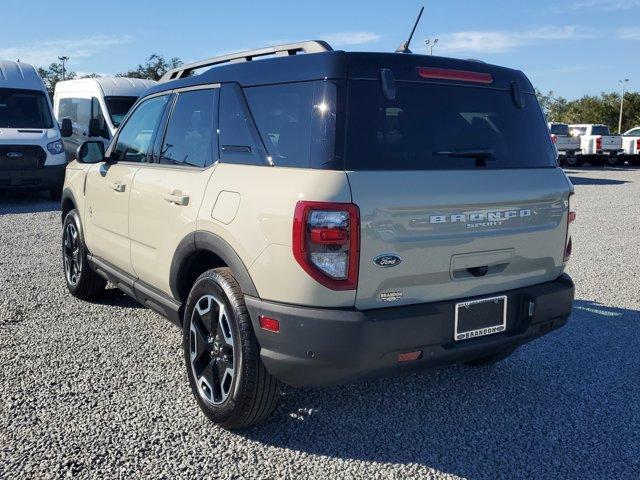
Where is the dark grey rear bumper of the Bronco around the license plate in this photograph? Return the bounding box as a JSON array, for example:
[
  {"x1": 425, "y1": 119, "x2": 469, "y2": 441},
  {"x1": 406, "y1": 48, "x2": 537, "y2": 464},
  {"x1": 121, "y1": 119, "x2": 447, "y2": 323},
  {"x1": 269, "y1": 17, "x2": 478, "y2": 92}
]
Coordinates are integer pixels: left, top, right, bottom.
[{"x1": 246, "y1": 275, "x2": 574, "y2": 387}]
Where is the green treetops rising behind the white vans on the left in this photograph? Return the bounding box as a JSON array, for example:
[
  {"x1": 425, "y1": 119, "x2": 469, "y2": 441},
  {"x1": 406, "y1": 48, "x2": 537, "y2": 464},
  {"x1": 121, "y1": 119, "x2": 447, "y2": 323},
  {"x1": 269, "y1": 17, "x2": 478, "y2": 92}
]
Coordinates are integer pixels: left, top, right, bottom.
[{"x1": 38, "y1": 53, "x2": 182, "y2": 98}]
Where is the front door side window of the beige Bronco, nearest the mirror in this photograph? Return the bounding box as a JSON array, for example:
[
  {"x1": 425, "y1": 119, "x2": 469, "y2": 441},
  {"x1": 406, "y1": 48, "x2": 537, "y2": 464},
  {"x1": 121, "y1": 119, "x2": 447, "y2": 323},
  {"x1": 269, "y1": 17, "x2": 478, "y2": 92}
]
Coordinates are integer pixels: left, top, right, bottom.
[{"x1": 111, "y1": 95, "x2": 169, "y2": 162}]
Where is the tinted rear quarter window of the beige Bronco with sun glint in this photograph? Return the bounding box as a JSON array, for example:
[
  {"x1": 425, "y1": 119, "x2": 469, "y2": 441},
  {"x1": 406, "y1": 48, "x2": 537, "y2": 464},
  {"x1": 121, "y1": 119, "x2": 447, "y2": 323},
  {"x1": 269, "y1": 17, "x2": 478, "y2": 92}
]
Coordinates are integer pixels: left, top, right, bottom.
[{"x1": 244, "y1": 81, "x2": 340, "y2": 168}]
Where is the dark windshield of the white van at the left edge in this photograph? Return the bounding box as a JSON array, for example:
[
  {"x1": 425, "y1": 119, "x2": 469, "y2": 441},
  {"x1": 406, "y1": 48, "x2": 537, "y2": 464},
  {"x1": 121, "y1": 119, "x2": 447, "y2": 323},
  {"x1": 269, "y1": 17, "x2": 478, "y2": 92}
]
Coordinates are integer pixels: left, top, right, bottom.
[{"x1": 0, "y1": 88, "x2": 53, "y2": 128}]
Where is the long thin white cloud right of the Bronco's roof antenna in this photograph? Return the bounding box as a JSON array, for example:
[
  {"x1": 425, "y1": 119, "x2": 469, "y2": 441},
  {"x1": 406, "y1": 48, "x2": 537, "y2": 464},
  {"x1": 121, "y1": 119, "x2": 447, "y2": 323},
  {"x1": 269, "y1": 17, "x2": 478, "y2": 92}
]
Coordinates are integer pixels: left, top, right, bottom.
[{"x1": 438, "y1": 25, "x2": 594, "y2": 53}]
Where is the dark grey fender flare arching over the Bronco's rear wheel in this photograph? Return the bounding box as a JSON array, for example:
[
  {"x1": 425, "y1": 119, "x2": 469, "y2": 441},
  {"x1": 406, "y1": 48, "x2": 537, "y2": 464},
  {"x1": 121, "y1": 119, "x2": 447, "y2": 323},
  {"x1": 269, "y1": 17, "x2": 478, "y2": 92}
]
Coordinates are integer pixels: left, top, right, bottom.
[{"x1": 169, "y1": 231, "x2": 258, "y2": 301}]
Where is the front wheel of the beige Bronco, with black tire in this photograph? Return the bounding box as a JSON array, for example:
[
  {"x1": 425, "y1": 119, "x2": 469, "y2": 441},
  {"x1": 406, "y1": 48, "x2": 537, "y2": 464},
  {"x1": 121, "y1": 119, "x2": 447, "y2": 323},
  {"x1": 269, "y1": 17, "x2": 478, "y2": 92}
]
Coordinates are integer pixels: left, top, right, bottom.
[{"x1": 62, "y1": 209, "x2": 107, "y2": 300}]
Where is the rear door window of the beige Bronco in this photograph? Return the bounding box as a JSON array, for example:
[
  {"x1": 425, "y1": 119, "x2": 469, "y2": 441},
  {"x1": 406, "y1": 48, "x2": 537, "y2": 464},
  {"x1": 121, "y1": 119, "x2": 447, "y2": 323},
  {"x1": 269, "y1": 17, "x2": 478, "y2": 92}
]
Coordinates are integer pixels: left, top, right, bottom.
[{"x1": 160, "y1": 89, "x2": 218, "y2": 167}]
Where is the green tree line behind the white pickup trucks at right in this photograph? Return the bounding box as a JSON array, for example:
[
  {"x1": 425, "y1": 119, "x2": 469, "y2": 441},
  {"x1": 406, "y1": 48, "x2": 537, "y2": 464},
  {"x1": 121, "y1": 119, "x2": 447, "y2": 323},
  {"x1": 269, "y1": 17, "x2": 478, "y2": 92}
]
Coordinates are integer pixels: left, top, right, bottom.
[{"x1": 536, "y1": 91, "x2": 640, "y2": 133}]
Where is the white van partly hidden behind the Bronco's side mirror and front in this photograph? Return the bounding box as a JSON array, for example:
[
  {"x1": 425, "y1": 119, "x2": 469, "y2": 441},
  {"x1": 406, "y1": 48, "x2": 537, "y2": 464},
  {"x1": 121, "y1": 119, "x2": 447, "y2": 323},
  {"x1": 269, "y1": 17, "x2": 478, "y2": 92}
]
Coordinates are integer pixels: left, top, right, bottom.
[{"x1": 53, "y1": 77, "x2": 156, "y2": 161}]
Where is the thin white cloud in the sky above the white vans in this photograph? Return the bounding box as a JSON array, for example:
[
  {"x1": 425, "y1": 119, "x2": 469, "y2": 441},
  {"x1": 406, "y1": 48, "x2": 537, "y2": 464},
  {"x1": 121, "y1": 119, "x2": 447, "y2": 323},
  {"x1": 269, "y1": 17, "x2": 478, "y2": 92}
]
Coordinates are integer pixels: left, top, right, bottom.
[{"x1": 0, "y1": 35, "x2": 131, "y2": 67}]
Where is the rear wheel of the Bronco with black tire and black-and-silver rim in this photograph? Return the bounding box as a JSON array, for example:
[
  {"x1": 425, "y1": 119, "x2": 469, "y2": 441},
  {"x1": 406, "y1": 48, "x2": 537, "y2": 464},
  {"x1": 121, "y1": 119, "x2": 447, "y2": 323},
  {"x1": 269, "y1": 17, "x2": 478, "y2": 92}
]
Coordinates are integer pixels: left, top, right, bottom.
[{"x1": 182, "y1": 268, "x2": 280, "y2": 430}]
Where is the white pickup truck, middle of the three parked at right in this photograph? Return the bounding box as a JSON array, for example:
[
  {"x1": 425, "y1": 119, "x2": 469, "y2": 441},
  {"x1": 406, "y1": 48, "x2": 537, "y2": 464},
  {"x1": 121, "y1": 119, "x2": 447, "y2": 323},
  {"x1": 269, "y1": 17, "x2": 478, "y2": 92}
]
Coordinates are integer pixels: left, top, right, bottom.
[{"x1": 569, "y1": 124, "x2": 624, "y2": 166}]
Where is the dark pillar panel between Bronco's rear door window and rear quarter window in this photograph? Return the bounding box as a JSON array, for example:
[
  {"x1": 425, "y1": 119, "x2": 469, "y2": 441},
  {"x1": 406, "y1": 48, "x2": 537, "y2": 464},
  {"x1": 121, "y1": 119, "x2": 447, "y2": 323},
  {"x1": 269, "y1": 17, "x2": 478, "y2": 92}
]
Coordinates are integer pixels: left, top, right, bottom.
[{"x1": 219, "y1": 84, "x2": 265, "y2": 165}]
